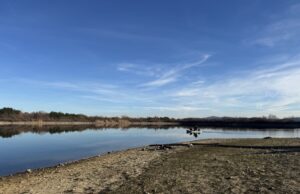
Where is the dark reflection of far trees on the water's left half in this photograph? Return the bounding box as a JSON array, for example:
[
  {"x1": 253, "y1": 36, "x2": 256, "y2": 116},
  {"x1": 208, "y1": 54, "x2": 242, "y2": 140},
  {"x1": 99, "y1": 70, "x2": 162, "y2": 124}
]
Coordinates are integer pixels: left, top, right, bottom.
[{"x1": 0, "y1": 125, "x2": 178, "y2": 138}]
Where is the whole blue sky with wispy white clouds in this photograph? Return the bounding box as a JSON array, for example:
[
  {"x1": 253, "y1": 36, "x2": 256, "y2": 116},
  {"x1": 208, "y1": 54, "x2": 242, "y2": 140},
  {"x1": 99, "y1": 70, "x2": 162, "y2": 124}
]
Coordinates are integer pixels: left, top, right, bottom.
[{"x1": 0, "y1": 0, "x2": 300, "y2": 118}]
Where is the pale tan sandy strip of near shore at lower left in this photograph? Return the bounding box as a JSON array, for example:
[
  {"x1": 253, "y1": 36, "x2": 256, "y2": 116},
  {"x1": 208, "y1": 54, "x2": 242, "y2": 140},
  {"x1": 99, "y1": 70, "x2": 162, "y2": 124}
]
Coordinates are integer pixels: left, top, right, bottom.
[{"x1": 0, "y1": 148, "x2": 161, "y2": 194}]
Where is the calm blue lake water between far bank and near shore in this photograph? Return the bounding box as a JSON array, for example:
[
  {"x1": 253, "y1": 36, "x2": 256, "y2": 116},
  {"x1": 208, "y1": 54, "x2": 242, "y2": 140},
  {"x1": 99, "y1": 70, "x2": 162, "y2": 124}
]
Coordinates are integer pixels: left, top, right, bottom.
[{"x1": 0, "y1": 127, "x2": 300, "y2": 175}]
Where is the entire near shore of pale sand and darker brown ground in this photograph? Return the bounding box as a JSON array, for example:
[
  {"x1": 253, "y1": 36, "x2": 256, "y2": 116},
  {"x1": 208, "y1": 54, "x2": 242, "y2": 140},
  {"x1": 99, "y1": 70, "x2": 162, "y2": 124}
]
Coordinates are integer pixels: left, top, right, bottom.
[{"x1": 0, "y1": 138, "x2": 300, "y2": 194}]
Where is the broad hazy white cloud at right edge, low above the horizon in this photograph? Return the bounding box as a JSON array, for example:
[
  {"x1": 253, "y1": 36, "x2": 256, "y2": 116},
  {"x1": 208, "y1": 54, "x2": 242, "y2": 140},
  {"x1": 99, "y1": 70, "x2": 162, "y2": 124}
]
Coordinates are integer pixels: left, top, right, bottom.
[{"x1": 171, "y1": 57, "x2": 300, "y2": 114}]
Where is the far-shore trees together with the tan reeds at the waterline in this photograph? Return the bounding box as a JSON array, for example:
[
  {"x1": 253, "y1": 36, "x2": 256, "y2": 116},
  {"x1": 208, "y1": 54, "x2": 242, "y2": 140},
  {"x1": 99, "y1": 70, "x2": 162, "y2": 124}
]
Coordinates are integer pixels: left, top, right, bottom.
[{"x1": 0, "y1": 108, "x2": 300, "y2": 128}]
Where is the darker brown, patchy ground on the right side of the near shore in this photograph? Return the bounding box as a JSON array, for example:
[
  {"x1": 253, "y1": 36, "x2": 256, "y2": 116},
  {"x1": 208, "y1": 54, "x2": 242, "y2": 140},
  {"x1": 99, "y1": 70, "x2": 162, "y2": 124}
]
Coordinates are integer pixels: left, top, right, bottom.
[{"x1": 112, "y1": 139, "x2": 300, "y2": 193}]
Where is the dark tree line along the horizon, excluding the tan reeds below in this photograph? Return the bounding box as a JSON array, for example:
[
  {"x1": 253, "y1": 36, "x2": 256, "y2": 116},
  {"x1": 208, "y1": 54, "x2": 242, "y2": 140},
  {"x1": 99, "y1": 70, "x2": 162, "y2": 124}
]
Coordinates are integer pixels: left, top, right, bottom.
[{"x1": 0, "y1": 107, "x2": 300, "y2": 128}]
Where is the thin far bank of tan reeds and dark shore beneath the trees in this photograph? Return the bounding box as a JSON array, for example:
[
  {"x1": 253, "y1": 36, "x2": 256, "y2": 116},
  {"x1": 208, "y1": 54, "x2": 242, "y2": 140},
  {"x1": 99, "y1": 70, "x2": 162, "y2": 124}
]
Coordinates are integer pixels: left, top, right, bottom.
[{"x1": 0, "y1": 120, "x2": 300, "y2": 130}]
